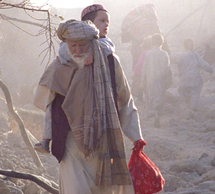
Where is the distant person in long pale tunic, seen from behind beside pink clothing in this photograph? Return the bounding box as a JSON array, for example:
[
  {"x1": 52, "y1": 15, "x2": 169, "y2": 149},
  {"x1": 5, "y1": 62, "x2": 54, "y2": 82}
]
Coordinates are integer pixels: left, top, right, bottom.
[{"x1": 142, "y1": 33, "x2": 171, "y2": 127}]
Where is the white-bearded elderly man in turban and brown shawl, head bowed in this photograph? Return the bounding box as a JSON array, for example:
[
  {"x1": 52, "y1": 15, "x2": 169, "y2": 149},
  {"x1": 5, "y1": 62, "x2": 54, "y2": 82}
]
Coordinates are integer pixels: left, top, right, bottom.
[{"x1": 35, "y1": 20, "x2": 143, "y2": 194}]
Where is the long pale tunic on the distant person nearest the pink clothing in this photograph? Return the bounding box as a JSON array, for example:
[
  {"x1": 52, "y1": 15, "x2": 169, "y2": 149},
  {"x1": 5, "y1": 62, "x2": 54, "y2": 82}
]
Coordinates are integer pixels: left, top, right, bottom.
[{"x1": 142, "y1": 48, "x2": 170, "y2": 113}]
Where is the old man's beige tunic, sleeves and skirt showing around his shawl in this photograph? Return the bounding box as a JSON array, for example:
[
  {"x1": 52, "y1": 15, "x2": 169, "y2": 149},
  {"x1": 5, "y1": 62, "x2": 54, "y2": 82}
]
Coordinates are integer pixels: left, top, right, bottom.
[{"x1": 35, "y1": 55, "x2": 143, "y2": 194}]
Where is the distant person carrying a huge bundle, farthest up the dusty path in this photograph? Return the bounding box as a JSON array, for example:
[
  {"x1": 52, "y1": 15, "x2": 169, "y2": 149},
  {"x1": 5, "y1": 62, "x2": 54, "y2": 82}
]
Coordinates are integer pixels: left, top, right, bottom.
[{"x1": 121, "y1": 3, "x2": 170, "y2": 70}]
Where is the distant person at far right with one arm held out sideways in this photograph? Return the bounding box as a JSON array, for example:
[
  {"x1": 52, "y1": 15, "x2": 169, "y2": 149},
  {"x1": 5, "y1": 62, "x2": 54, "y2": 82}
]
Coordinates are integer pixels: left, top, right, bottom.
[{"x1": 176, "y1": 39, "x2": 212, "y2": 110}]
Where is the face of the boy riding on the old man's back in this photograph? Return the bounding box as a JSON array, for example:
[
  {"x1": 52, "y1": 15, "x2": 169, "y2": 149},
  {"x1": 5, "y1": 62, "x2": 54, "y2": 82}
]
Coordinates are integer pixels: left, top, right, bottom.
[{"x1": 93, "y1": 11, "x2": 110, "y2": 37}]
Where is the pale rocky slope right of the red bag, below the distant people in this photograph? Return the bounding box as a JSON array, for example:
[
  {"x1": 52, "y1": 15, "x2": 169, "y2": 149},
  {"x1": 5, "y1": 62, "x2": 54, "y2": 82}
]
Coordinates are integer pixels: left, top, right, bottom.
[{"x1": 127, "y1": 76, "x2": 215, "y2": 194}]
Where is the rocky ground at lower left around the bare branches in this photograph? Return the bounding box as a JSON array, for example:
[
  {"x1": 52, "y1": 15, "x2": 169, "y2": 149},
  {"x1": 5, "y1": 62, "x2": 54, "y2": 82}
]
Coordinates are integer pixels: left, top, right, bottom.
[{"x1": 0, "y1": 94, "x2": 58, "y2": 194}]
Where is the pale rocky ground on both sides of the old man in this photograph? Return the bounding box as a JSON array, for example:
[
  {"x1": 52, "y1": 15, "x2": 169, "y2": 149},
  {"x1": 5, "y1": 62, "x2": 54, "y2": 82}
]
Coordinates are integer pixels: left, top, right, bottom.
[{"x1": 0, "y1": 66, "x2": 215, "y2": 194}]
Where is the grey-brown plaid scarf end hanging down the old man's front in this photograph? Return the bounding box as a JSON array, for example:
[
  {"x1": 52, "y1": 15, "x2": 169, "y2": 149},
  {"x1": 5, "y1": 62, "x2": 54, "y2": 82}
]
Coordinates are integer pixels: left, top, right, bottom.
[{"x1": 94, "y1": 40, "x2": 131, "y2": 187}]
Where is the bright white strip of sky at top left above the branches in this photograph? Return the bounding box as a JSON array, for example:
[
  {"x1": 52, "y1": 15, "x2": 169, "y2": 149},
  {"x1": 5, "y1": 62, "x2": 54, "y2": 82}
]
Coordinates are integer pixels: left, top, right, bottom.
[{"x1": 31, "y1": 0, "x2": 93, "y2": 8}]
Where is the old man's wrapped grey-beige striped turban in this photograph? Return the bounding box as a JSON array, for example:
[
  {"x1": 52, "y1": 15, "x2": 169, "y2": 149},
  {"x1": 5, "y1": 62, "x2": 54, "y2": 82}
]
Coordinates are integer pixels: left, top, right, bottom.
[{"x1": 57, "y1": 20, "x2": 99, "y2": 42}]
